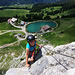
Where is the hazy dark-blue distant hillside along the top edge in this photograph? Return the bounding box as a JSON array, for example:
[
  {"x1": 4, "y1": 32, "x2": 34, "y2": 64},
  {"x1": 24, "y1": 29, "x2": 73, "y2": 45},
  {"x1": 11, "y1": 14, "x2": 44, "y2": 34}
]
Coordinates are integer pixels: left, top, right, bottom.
[{"x1": 0, "y1": 0, "x2": 75, "y2": 6}]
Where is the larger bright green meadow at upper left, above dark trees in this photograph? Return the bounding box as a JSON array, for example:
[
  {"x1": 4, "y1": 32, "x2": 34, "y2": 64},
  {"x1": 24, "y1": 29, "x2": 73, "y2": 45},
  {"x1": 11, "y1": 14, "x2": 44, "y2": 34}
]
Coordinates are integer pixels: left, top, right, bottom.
[{"x1": 0, "y1": 9, "x2": 29, "y2": 17}]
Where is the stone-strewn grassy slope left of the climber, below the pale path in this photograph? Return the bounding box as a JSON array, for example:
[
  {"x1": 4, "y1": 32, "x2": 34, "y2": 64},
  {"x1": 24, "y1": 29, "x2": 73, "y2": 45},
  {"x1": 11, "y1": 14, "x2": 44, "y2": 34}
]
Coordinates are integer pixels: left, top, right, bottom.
[{"x1": 0, "y1": 40, "x2": 41, "y2": 70}]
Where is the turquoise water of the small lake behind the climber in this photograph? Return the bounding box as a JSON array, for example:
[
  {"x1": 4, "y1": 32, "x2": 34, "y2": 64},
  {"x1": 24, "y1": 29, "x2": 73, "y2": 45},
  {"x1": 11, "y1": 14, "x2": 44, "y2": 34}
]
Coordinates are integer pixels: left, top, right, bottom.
[{"x1": 27, "y1": 21, "x2": 56, "y2": 33}]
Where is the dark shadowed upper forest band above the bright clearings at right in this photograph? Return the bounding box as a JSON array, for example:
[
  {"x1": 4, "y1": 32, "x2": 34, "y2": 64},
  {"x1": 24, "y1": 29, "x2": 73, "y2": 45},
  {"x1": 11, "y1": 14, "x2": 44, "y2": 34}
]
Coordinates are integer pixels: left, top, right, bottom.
[{"x1": 30, "y1": 2, "x2": 75, "y2": 12}]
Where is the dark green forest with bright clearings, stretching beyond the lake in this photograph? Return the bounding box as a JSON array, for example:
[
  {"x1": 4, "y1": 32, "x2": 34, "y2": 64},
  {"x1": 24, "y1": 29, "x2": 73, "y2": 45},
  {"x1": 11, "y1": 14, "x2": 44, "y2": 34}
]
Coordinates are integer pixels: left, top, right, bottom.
[{"x1": 0, "y1": 2, "x2": 75, "y2": 22}]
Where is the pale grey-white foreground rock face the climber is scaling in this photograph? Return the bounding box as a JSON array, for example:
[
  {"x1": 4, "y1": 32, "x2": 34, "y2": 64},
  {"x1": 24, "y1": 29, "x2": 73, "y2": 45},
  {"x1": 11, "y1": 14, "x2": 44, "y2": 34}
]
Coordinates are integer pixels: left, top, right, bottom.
[{"x1": 5, "y1": 42, "x2": 75, "y2": 75}]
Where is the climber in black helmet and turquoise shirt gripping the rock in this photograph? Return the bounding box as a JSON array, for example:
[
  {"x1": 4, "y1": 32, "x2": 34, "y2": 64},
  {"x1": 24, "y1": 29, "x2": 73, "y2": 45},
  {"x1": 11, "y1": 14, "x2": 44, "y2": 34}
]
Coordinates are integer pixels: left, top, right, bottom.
[{"x1": 26, "y1": 35, "x2": 42, "y2": 67}]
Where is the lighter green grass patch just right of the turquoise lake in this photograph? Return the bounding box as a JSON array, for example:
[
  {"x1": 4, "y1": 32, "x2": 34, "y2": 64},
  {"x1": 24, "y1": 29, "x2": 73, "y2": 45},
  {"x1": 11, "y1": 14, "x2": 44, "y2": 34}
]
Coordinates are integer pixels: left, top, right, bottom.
[{"x1": 55, "y1": 18, "x2": 75, "y2": 32}]
